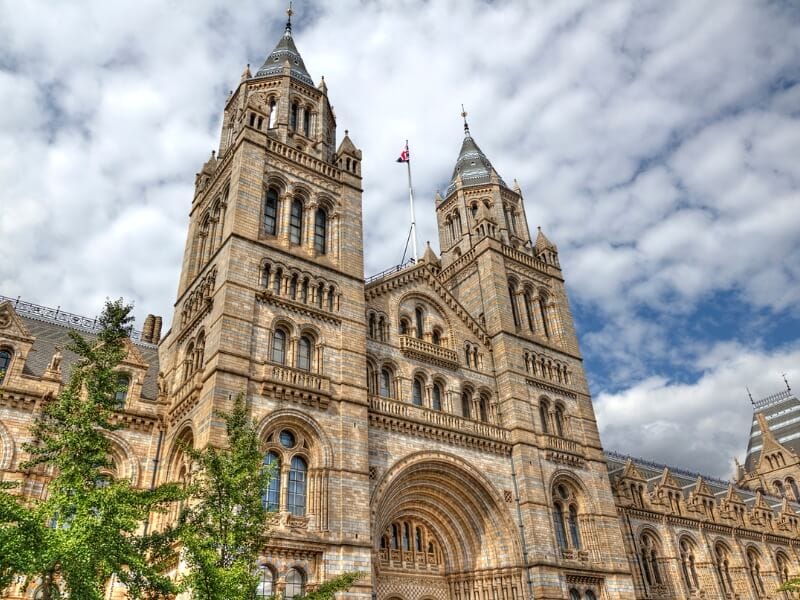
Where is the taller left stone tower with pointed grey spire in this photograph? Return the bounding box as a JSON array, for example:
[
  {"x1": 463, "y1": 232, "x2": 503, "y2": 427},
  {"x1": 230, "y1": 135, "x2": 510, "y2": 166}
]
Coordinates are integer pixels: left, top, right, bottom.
[{"x1": 160, "y1": 11, "x2": 369, "y2": 597}]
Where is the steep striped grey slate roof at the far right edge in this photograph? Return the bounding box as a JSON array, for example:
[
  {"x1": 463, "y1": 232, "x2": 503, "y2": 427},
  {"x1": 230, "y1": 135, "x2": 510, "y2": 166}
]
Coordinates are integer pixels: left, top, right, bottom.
[{"x1": 744, "y1": 389, "x2": 800, "y2": 473}]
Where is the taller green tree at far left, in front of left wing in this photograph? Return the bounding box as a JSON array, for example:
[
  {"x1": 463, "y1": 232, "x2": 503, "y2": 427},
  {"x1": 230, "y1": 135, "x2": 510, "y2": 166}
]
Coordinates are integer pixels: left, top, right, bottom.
[{"x1": 0, "y1": 299, "x2": 182, "y2": 600}]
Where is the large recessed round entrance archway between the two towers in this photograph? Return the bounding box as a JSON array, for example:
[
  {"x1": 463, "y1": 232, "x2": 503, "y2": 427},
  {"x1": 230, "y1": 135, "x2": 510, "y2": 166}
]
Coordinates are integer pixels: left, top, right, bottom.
[{"x1": 371, "y1": 452, "x2": 525, "y2": 600}]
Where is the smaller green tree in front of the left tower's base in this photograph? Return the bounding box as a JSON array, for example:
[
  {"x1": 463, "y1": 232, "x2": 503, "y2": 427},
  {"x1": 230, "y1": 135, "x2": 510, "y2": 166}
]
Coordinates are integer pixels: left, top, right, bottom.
[{"x1": 180, "y1": 394, "x2": 362, "y2": 600}]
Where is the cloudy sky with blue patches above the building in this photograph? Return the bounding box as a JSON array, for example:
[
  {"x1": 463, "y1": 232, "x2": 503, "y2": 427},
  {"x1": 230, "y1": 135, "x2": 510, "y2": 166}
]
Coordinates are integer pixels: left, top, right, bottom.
[{"x1": 0, "y1": 0, "x2": 800, "y2": 477}]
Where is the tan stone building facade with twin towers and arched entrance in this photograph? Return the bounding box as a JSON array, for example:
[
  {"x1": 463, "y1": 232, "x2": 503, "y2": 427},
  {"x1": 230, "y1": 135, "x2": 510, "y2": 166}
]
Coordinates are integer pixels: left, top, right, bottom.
[{"x1": 0, "y1": 11, "x2": 800, "y2": 600}]
